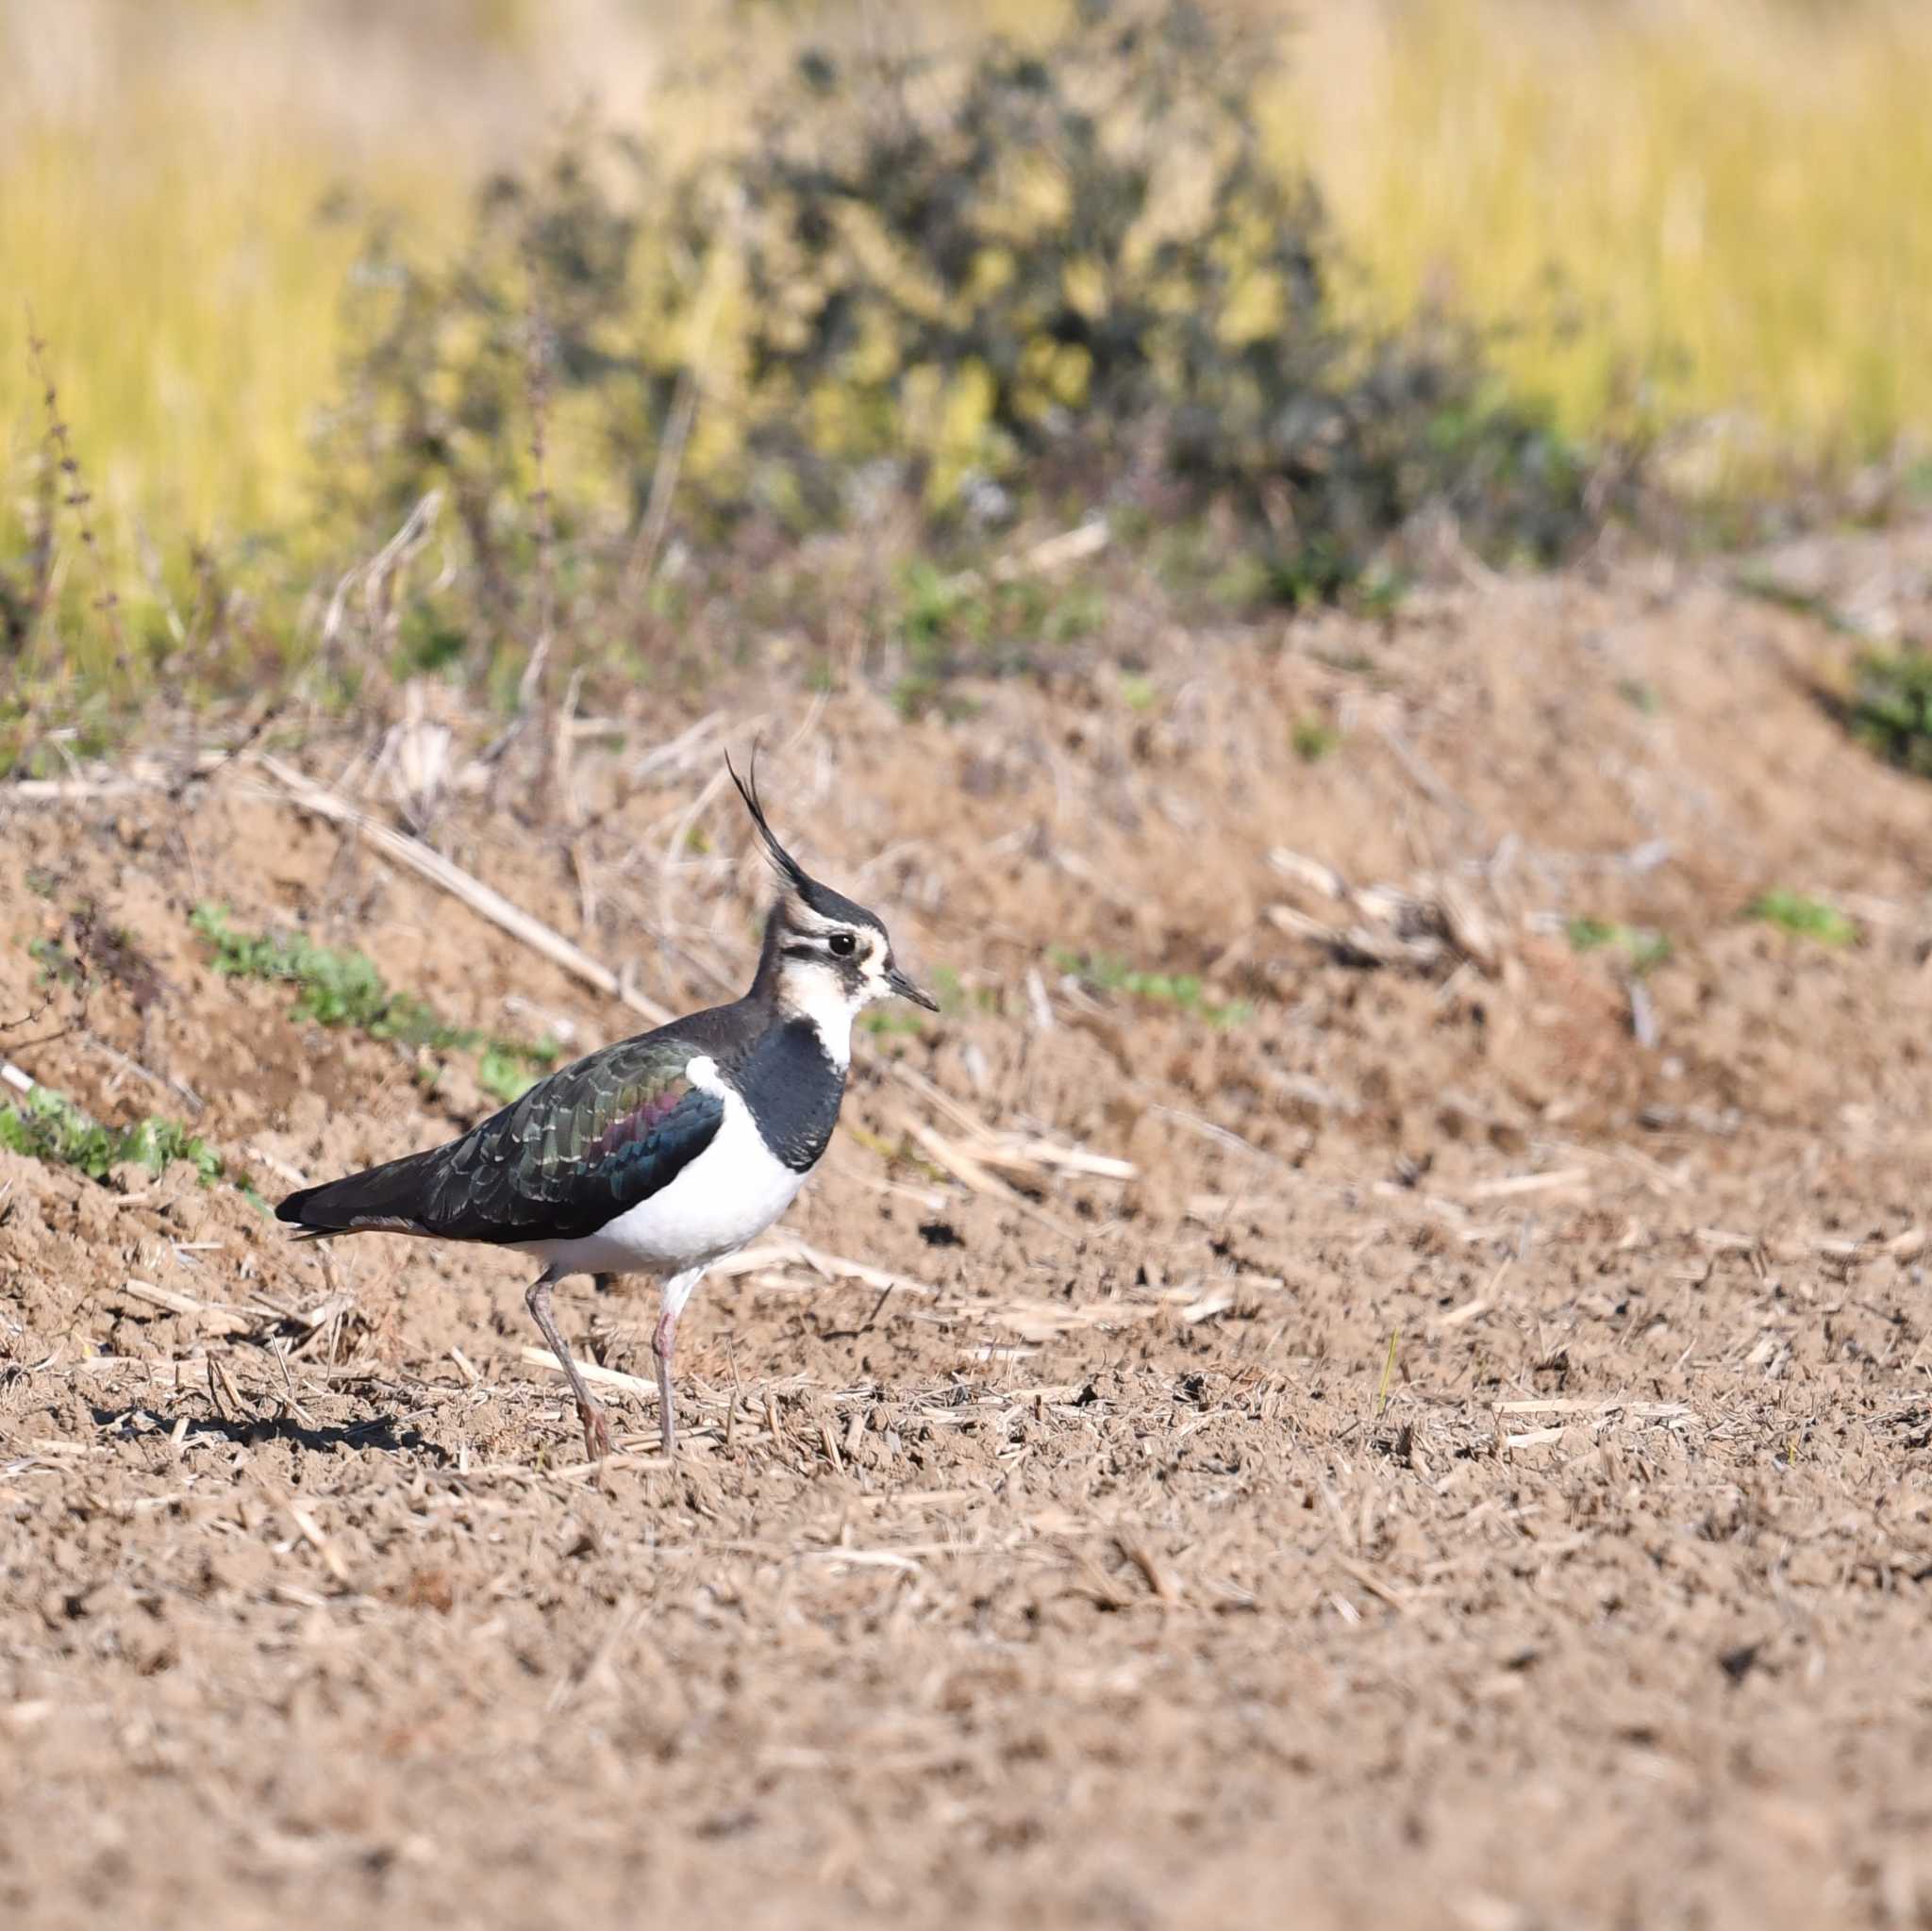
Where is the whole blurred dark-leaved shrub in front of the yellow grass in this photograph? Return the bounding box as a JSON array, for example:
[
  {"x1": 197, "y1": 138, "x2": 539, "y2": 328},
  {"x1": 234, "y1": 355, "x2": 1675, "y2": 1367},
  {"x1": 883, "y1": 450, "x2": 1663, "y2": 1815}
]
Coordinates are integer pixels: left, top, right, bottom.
[{"x1": 328, "y1": 0, "x2": 1586, "y2": 627}]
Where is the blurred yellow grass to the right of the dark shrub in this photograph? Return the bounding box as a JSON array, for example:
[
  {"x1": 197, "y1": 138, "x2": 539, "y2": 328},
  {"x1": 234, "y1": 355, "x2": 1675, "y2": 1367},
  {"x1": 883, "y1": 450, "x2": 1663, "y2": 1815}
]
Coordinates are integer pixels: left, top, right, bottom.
[{"x1": 1281, "y1": 0, "x2": 1932, "y2": 483}]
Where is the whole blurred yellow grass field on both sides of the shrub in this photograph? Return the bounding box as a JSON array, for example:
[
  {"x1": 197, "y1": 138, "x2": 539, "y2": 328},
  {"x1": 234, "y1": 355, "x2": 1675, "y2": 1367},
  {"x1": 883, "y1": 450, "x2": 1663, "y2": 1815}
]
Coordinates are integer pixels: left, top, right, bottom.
[{"x1": 0, "y1": 0, "x2": 1932, "y2": 562}]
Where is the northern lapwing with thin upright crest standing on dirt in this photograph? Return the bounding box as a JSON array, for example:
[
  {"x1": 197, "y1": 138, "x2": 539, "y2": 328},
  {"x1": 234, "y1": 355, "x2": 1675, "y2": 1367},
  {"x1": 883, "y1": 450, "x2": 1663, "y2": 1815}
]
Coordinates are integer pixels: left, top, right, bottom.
[{"x1": 276, "y1": 755, "x2": 939, "y2": 1460}]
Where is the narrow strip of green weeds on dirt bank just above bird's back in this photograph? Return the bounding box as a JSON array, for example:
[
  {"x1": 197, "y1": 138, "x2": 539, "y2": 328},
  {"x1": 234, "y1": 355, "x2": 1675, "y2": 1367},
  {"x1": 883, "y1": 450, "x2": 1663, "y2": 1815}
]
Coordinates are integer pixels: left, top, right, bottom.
[{"x1": 190, "y1": 906, "x2": 558, "y2": 1105}]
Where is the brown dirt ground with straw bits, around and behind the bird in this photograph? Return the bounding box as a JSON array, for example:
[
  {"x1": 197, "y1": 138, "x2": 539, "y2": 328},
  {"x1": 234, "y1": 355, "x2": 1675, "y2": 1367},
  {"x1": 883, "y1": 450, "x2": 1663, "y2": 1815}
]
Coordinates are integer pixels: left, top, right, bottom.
[{"x1": 0, "y1": 533, "x2": 1932, "y2": 1931}]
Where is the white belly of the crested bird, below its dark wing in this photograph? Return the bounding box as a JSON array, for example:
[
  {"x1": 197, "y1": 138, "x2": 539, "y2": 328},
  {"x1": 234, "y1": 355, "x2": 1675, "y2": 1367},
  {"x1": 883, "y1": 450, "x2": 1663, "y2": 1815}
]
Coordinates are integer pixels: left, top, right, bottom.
[{"x1": 524, "y1": 1093, "x2": 806, "y2": 1274}]
